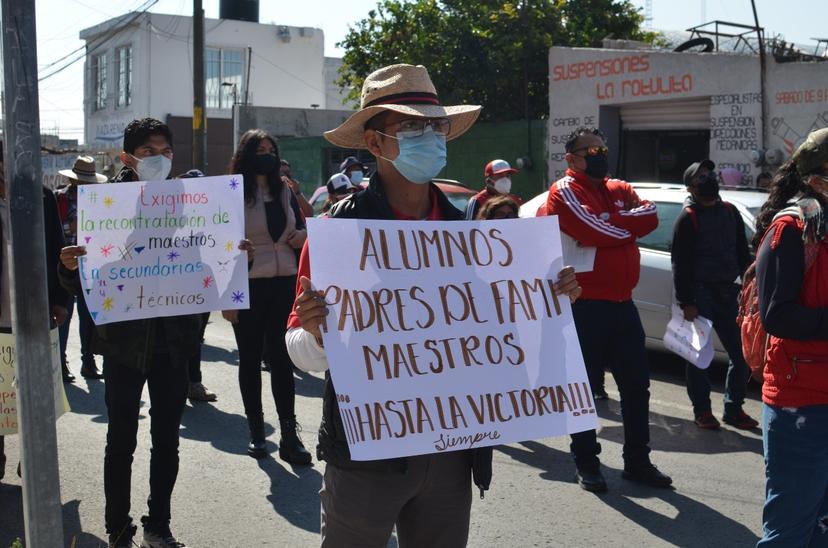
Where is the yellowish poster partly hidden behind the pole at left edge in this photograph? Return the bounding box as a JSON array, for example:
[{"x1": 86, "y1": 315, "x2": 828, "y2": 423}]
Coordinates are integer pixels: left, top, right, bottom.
[{"x1": 0, "y1": 329, "x2": 69, "y2": 436}]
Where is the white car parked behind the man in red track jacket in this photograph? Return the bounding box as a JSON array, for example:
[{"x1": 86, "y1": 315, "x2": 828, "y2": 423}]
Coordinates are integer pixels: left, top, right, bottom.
[{"x1": 520, "y1": 183, "x2": 768, "y2": 360}]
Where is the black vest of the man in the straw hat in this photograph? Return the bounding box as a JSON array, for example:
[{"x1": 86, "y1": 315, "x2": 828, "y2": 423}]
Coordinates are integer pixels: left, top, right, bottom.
[{"x1": 316, "y1": 175, "x2": 492, "y2": 497}]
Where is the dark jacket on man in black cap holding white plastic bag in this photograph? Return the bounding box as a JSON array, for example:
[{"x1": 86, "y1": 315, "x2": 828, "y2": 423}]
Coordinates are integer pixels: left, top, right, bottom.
[{"x1": 670, "y1": 198, "x2": 751, "y2": 306}]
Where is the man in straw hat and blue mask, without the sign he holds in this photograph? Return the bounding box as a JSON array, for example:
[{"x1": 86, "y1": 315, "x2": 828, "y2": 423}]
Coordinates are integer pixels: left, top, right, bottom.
[{"x1": 286, "y1": 65, "x2": 580, "y2": 547}]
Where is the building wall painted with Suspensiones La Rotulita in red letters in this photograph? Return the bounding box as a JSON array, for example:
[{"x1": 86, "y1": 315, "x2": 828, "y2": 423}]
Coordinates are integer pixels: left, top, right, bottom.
[{"x1": 547, "y1": 47, "x2": 828, "y2": 183}]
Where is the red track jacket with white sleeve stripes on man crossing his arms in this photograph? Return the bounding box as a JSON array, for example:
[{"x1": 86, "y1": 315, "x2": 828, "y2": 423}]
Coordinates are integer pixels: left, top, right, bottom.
[{"x1": 538, "y1": 169, "x2": 658, "y2": 302}]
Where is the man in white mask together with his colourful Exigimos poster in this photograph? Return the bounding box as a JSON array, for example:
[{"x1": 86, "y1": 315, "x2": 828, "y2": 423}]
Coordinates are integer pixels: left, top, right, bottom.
[{"x1": 60, "y1": 118, "x2": 253, "y2": 548}]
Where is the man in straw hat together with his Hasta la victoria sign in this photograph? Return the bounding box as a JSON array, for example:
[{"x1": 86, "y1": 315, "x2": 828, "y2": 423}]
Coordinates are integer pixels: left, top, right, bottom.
[{"x1": 286, "y1": 65, "x2": 584, "y2": 547}]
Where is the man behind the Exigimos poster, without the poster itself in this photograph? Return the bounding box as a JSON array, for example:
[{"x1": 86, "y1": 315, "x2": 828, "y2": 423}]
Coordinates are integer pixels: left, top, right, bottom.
[{"x1": 59, "y1": 118, "x2": 253, "y2": 548}]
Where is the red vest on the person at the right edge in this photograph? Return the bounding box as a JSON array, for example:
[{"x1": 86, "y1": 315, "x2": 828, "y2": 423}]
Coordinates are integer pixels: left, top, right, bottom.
[{"x1": 757, "y1": 217, "x2": 828, "y2": 407}]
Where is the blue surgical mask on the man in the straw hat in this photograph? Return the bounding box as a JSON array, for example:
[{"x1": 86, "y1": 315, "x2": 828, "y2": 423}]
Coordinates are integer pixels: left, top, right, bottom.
[{"x1": 377, "y1": 126, "x2": 446, "y2": 185}]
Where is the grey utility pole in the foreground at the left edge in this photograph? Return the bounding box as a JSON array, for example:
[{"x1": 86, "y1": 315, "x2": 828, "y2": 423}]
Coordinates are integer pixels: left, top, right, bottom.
[{"x1": 0, "y1": 0, "x2": 64, "y2": 548}]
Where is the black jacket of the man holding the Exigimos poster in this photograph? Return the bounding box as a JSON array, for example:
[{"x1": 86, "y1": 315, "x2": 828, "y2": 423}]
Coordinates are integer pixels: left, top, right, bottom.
[{"x1": 58, "y1": 167, "x2": 203, "y2": 371}]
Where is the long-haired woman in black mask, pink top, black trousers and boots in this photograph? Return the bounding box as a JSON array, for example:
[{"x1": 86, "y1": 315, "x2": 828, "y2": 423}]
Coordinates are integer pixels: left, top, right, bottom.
[{"x1": 222, "y1": 129, "x2": 311, "y2": 464}]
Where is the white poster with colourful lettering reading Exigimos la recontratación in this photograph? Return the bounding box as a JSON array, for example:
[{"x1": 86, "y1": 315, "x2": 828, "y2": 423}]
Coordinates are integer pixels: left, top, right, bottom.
[{"x1": 78, "y1": 175, "x2": 250, "y2": 325}]
